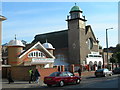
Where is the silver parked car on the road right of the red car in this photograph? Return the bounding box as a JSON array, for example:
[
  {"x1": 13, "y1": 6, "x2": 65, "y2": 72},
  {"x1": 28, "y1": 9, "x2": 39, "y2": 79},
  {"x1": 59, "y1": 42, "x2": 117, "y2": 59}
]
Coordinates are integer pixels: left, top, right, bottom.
[{"x1": 95, "y1": 68, "x2": 112, "y2": 77}]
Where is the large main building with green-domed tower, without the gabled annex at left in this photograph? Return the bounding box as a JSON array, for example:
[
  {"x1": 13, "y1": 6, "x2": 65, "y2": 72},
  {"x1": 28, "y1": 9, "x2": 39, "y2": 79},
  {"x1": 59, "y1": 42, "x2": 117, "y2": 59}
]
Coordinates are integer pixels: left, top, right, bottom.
[{"x1": 32, "y1": 5, "x2": 103, "y2": 69}]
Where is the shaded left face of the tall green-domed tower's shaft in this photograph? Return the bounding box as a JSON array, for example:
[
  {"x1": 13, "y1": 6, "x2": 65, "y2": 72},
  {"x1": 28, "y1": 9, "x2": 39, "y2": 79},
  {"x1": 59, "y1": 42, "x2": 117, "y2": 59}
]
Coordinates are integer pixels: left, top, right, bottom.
[{"x1": 68, "y1": 19, "x2": 80, "y2": 64}]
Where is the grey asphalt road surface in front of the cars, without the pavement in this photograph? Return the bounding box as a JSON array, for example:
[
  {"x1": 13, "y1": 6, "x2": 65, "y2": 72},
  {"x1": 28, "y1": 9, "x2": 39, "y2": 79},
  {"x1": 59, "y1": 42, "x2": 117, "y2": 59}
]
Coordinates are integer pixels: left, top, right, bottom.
[{"x1": 39, "y1": 75, "x2": 120, "y2": 88}]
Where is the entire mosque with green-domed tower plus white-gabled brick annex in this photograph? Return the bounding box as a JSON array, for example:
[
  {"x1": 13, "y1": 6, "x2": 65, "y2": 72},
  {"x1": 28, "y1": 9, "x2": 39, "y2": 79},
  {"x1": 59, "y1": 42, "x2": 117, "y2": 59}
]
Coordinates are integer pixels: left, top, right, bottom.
[{"x1": 3, "y1": 5, "x2": 103, "y2": 79}]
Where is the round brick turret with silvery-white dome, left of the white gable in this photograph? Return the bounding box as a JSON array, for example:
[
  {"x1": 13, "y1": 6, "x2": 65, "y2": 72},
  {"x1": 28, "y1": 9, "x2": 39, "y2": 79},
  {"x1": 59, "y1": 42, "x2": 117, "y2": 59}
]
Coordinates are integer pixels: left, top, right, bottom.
[{"x1": 7, "y1": 35, "x2": 24, "y2": 66}]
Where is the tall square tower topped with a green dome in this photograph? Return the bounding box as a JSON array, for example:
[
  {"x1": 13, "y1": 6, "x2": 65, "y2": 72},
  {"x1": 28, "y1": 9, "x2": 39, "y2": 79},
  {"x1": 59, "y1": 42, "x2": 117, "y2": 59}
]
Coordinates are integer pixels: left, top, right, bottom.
[{"x1": 66, "y1": 4, "x2": 87, "y2": 64}]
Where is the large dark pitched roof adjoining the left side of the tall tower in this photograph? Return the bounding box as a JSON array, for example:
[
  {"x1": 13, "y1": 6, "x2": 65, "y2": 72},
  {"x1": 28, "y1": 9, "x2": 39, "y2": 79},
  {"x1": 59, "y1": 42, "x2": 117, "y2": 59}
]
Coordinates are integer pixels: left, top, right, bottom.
[{"x1": 33, "y1": 30, "x2": 68, "y2": 49}]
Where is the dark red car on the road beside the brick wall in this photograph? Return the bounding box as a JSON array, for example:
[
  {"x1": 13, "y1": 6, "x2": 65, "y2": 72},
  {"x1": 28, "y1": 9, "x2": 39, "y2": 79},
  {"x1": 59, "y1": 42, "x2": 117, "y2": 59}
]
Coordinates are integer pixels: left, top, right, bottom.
[{"x1": 44, "y1": 71, "x2": 81, "y2": 86}]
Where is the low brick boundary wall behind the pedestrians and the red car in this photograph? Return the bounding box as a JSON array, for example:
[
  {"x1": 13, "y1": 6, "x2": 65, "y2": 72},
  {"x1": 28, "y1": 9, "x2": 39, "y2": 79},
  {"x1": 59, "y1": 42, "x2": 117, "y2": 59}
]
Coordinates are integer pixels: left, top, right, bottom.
[{"x1": 7, "y1": 66, "x2": 58, "y2": 81}]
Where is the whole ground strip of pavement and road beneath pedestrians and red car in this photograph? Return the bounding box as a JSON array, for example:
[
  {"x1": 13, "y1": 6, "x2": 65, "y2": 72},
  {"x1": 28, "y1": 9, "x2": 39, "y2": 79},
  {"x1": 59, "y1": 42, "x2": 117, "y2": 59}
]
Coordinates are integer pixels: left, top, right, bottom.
[{"x1": 2, "y1": 75, "x2": 120, "y2": 89}]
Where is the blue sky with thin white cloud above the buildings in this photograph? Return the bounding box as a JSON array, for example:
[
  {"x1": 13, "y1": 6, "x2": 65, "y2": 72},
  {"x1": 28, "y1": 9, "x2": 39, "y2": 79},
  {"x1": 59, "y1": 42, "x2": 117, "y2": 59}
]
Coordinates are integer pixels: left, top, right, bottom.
[{"x1": 2, "y1": 2, "x2": 118, "y2": 48}]
